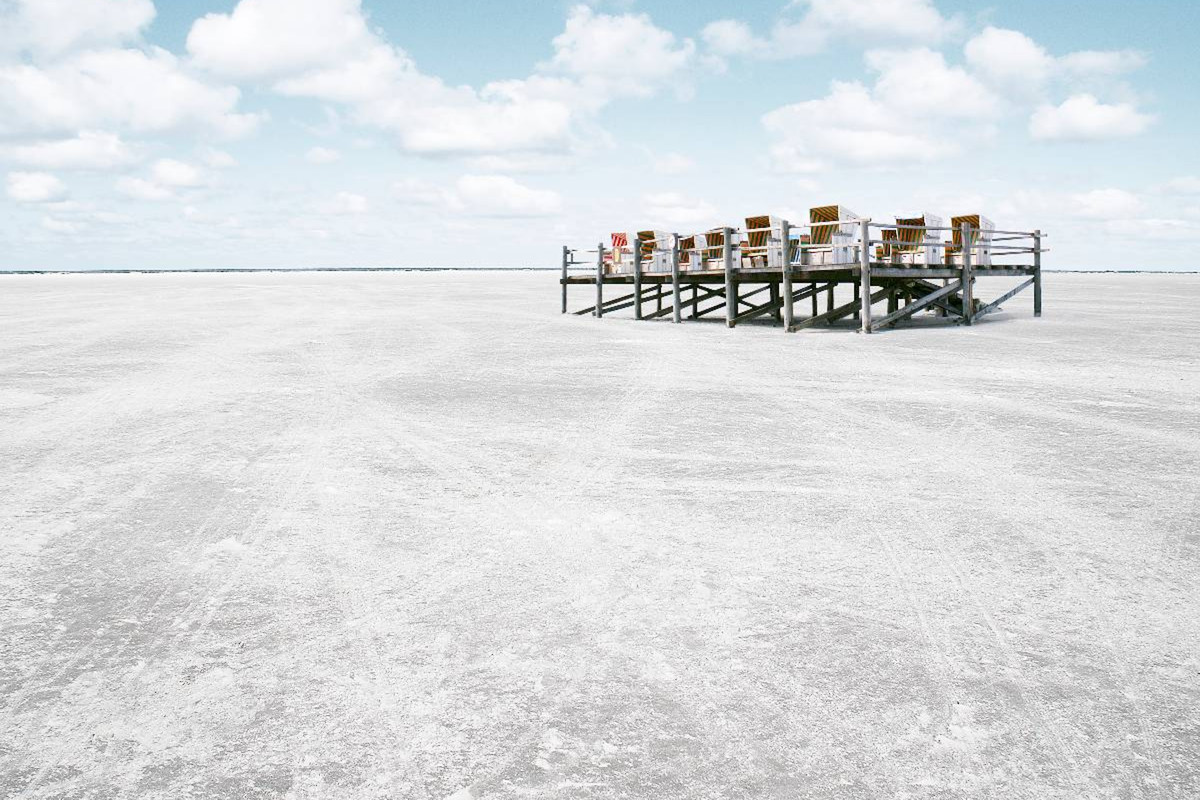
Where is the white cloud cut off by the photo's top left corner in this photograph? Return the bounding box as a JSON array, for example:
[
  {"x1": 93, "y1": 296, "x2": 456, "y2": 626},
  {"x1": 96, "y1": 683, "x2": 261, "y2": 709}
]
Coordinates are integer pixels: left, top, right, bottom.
[{"x1": 0, "y1": 0, "x2": 155, "y2": 58}]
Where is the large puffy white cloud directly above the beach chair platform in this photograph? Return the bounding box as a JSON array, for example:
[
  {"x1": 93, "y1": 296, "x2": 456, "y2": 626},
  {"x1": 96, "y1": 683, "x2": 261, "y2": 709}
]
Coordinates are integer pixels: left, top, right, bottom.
[{"x1": 762, "y1": 48, "x2": 1000, "y2": 173}]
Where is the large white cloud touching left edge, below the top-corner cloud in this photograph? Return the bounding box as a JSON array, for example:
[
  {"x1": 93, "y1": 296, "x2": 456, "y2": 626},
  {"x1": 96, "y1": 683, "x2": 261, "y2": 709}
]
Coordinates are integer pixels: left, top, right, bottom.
[{"x1": 0, "y1": 48, "x2": 258, "y2": 137}]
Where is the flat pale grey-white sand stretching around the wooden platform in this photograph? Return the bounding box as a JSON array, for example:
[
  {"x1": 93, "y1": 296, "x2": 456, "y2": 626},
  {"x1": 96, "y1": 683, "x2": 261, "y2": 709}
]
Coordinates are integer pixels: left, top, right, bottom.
[{"x1": 0, "y1": 272, "x2": 1200, "y2": 800}]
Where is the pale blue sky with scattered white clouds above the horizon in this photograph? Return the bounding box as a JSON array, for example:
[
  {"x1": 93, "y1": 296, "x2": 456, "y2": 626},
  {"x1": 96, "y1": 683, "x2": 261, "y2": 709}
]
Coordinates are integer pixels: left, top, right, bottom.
[{"x1": 0, "y1": 0, "x2": 1200, "y2": 270}]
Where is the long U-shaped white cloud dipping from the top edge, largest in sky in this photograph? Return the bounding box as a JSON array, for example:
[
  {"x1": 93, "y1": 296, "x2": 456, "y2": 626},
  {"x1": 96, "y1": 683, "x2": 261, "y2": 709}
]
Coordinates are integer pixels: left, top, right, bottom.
[{"x1": 187, "y1": 0, "x2": 695, "y2": 156}]
